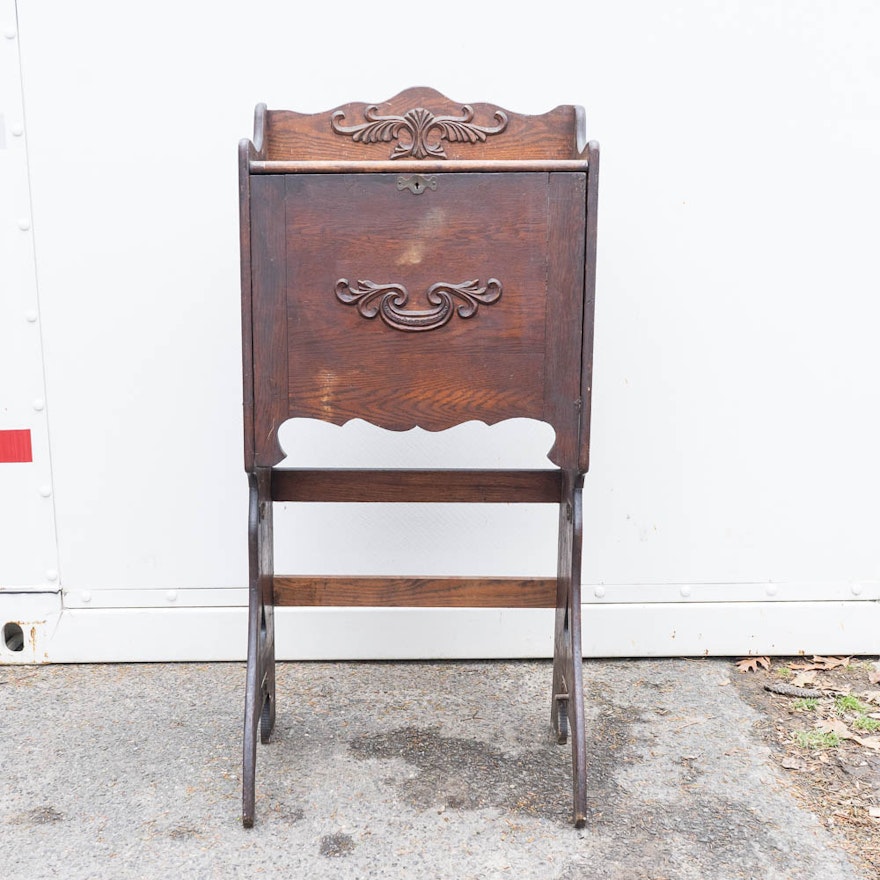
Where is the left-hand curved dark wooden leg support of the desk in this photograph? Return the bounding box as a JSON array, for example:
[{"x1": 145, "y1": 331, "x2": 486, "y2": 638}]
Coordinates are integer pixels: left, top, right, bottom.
[{"x1": 242, "y1": 468, "x2": 275, "y2": 828}]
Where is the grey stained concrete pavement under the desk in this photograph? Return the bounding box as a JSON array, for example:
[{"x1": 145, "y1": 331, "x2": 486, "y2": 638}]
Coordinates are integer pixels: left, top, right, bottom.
[{"x1": 0, "y1": 660, "x2": 864, "y2": 880}]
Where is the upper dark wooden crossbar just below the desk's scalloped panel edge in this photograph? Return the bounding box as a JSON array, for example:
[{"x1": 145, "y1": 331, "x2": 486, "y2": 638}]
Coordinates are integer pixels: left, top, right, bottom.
[{"x1": 272, "y1": 468, "x2": 561, "y2": 504}]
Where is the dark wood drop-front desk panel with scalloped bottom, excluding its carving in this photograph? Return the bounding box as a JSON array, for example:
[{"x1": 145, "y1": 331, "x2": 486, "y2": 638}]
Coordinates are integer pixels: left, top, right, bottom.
[{"x1": 251, "y1": 172, "x2": 586, "y2": 467}]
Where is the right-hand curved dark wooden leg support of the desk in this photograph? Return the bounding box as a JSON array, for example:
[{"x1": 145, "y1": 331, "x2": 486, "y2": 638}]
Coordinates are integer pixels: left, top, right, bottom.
[{"x1": 550, "y1": 473, "x2": 587, "y2": 828}]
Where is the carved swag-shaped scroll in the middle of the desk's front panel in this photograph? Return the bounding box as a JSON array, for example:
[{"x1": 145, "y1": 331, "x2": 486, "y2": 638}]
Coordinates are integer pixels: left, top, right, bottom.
[{"x1": 336, "y1": 278, "x2": 501, "y2": 331}]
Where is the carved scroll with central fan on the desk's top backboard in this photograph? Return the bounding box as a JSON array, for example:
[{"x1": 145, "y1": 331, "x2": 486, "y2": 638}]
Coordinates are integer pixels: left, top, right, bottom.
[{"x1": 330, "y1": 104, "x2": 507, "y2": 159}]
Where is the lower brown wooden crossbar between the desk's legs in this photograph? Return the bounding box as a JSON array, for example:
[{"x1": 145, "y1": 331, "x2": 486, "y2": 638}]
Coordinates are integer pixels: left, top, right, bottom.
[{"x1": 274, "y1": 575, "x2": 556, "y2": 608}]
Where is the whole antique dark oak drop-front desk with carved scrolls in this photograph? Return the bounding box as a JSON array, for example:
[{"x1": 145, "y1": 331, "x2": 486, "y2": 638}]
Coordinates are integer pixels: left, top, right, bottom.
[{"x1": 239, "y1": 89, "x2": 599, "y2": 827}]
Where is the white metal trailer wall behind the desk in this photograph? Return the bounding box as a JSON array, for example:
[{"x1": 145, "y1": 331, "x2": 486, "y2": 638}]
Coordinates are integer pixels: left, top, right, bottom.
[{"x1": 0, "y1": 0, "x2": 880, "y2": 662}]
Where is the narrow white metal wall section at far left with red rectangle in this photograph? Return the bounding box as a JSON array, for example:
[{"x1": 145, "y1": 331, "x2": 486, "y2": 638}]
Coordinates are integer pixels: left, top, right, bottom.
[{"x1": 0, "y1": 0, "x2": 61, "y2": 660}]
